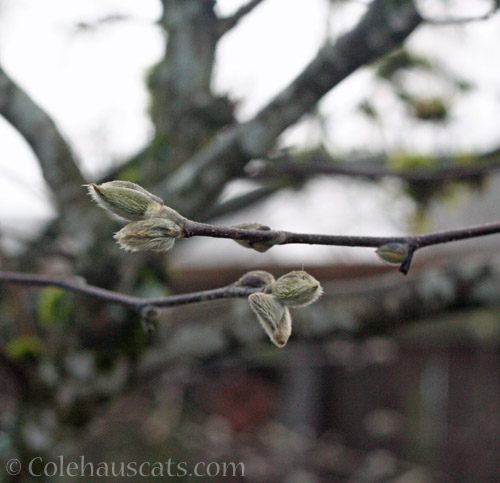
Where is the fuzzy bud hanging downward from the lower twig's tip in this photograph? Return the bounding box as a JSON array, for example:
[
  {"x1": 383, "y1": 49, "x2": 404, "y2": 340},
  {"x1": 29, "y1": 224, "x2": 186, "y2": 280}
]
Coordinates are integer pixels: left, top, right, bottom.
[{"x1": 248, "y1": 293, "x2": 292, "y2": 347}]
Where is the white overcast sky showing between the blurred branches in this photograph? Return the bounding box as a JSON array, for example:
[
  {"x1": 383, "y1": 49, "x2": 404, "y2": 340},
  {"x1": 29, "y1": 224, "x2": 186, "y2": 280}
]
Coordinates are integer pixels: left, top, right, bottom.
[{"x1": 0, "y1": 0, "x2": 500, "y2": 263}]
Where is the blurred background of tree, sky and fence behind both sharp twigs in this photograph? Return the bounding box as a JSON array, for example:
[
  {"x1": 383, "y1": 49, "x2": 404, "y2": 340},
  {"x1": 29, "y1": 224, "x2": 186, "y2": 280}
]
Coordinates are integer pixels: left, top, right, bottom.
[{"x1": 0, "y1": 0, "x2": 500, "y2": 483}]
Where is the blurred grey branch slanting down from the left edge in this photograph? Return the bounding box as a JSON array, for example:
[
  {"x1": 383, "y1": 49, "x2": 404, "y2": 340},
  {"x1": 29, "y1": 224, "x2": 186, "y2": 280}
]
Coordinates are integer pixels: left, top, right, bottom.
[{"x1": 0, "y1": 67, "x2": 85, "y2": 210}]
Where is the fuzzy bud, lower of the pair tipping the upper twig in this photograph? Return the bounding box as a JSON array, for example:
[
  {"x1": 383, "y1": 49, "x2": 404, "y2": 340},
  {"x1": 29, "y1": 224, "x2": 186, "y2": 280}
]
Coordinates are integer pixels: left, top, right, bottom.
[{"x1": 114, "y1": 218, "x2": 183, "y2": 252}]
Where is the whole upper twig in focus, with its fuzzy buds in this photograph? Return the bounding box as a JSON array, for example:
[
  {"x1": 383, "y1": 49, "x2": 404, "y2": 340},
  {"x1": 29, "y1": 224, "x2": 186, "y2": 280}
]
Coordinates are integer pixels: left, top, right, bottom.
[{"x1": 88, "y1": 181, "x2": 500, "y2": 274}]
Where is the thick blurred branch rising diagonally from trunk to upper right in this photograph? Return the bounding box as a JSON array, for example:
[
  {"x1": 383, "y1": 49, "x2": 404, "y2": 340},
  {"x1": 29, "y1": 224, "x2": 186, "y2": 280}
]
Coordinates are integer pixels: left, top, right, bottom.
[{"x1": 158, "y1": 0, "x2": 421, "y2": 216}]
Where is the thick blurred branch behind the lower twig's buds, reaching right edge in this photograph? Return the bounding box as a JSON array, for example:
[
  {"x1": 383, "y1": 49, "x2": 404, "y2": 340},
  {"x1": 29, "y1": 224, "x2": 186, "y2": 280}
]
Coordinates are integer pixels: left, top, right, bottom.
[{"x1": 139, "y1": 256, "x2": 500, "y2": 377}]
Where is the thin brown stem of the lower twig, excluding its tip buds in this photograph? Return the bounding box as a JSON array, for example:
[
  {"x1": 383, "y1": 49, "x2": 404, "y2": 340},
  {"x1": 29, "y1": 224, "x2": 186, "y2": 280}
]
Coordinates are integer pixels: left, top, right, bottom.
[{"x1": 0, "y1": 271, "x2": 260, "y2": 311}]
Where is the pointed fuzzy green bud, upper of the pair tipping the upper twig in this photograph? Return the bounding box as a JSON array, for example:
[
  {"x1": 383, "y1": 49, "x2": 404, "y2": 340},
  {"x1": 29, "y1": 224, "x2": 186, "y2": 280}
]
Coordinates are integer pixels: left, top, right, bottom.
[{"x1": 87, "y1": 181, "x2": 164, "y2": 221}]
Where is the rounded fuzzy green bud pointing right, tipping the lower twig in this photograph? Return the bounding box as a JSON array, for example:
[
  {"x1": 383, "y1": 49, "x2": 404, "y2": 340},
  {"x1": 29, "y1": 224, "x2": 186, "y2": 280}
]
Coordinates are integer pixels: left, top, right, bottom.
[{"x1": 272, "y1": 270, "x2": 323, "y2": 307}]
